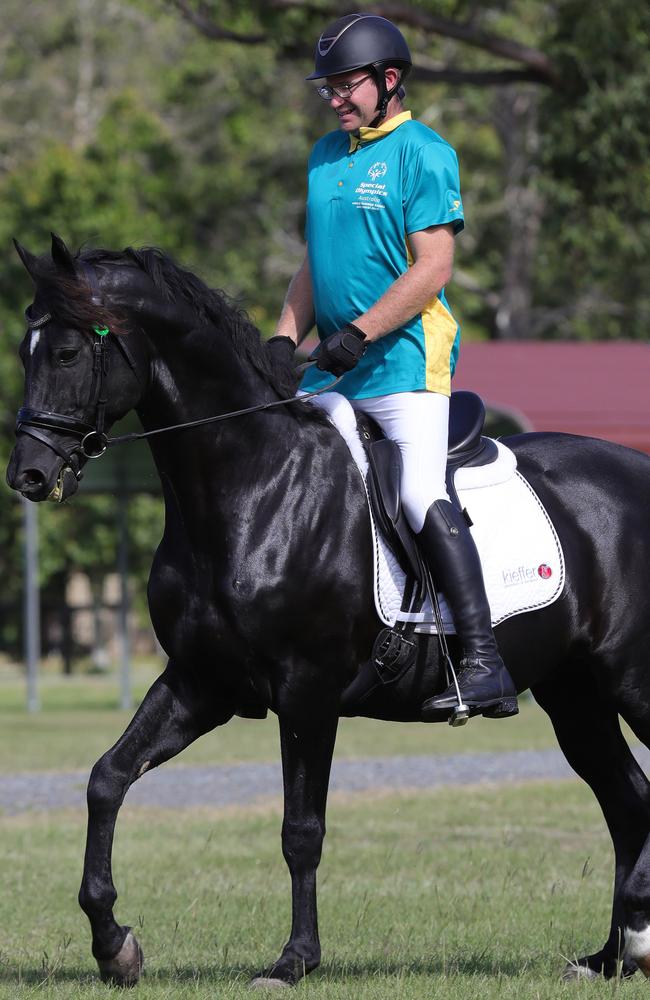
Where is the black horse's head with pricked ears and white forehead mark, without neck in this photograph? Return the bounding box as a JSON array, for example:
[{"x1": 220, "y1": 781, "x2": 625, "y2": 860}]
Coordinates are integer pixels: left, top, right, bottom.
[{"x1": 7, "y1": 234, "x2": 149, "y2": 502}]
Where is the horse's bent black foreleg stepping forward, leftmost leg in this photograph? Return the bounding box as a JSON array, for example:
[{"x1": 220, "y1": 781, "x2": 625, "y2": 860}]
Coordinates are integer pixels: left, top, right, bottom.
[{"x1": 79, "y1": 663, "x2": 232, "y2": 986}]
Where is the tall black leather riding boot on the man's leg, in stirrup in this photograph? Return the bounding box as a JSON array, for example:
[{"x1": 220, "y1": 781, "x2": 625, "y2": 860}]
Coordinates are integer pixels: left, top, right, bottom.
[{"x1": 417, "y1": 500, "x2": 518, "y2": 719}]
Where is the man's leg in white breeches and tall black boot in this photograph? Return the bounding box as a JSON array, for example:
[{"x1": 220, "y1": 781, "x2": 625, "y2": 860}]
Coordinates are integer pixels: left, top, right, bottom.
[{"x1": 352, "y1": 392, "x2": 517, "y2": 718}]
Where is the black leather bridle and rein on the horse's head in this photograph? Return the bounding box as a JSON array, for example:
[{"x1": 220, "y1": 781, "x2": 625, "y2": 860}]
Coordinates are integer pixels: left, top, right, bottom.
[{"x1": 16, "y1": 261, "x2": 343, "y2": 479}]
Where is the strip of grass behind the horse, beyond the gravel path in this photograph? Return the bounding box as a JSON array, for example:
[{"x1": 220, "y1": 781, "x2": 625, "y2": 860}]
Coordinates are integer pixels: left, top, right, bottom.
[{"x1": 0, "y1": 665, "x2": 556, "y2": 773}]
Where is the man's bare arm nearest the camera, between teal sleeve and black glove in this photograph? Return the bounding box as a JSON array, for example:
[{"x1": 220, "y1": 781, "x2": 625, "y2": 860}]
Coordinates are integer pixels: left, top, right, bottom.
[{"x1": 351, "y1": 225, "x2": 454, "y2": 340}]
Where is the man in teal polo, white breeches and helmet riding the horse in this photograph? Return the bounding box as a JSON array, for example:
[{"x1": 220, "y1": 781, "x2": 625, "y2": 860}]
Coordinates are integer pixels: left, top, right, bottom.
[{"x1": 273, "y1": 14, "x2": 517, "y2": 718}]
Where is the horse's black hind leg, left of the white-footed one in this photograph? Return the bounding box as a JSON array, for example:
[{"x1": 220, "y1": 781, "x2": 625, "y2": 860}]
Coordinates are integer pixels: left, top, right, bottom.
[{"x1": 533, "y1": 667, "x2": 650, "y2": 980}]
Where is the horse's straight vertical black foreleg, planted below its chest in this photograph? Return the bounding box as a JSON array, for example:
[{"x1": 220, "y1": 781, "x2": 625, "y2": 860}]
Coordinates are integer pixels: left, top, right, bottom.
[{"x1": 253, "y1": 716, "x2": 338, "y2": 986}]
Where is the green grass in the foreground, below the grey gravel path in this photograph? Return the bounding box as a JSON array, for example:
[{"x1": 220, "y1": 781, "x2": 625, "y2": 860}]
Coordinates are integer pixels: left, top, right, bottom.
[{"x1": 0, "y1": 782, "x2": 647, "y2": 1000}]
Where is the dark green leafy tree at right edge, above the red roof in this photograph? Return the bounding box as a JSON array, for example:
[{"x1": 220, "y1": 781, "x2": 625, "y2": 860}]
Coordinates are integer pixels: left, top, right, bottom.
[{"x1": 540, "y1": 0, "x2": 650, "y2": 339}]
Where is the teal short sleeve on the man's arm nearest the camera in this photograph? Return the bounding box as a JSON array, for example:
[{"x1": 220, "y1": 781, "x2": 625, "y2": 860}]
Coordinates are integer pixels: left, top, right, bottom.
[{"x1": 404, "y1": 142, "x2": 465, "y2": 235}]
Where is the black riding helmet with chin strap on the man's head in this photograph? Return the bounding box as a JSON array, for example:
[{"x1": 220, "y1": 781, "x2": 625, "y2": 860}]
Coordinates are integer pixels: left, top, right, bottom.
[{"x1": 306, "y1": 14, "x2": 412, "y2": 120}]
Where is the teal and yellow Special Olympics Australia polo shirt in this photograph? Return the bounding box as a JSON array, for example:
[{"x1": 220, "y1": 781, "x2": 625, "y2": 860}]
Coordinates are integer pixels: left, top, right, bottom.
[{"x1": 301, "y1": 111, "x2": 464, "y2": 399}]
